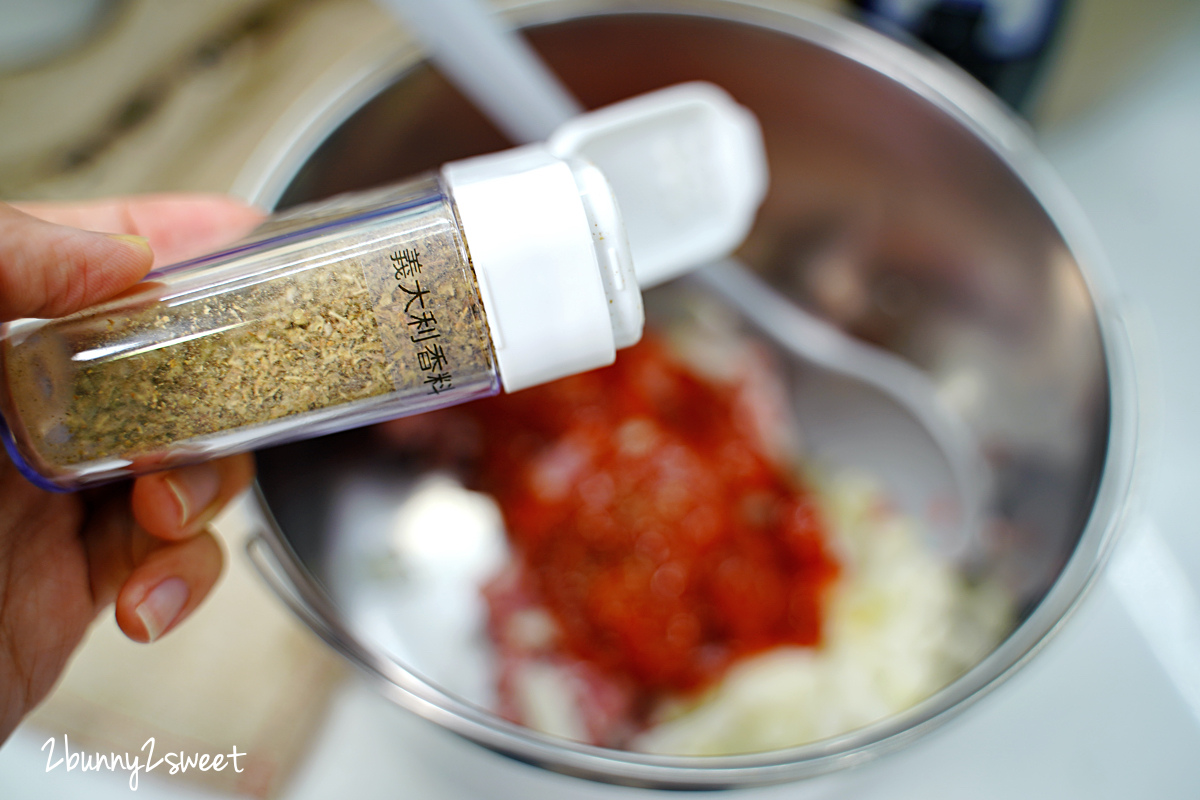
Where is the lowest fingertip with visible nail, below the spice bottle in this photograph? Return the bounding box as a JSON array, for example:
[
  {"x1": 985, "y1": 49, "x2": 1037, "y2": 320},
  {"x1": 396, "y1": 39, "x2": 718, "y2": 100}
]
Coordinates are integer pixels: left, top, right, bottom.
[{"x1": 116, "y1": 531, "x2": 223, "y2": 642}]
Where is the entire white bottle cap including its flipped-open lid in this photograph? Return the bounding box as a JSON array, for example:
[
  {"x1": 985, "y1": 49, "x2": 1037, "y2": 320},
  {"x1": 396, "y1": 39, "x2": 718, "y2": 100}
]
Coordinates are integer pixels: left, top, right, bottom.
[{"x1": 442, "y1": 83, "x2": 767, "y2": 392}]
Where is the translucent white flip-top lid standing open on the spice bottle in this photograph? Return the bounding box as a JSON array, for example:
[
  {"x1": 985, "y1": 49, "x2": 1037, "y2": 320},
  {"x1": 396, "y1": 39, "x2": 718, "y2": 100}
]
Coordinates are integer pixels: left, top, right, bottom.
[{"x1": 547, "y1": 83, "x2": 767, "y2": 288}]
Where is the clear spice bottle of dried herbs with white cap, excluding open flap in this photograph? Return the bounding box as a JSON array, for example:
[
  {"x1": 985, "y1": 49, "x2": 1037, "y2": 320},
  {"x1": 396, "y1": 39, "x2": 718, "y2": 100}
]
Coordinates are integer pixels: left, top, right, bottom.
[{"x1": 0, "y1": 145, "x2": 642, "y2": 491}]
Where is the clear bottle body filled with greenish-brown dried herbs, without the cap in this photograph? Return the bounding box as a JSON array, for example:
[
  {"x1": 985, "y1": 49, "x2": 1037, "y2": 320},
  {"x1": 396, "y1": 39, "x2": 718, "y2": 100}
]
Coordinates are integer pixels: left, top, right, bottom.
[{"x1": 2, "y1": 178, "x2": 496, "y2": 482}]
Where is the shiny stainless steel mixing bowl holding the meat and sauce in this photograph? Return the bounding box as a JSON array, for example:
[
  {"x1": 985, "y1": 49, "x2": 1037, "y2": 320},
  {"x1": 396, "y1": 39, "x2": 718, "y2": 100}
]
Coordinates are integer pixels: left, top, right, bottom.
[{"x1": 238, "y1": 0, "x2": 1138, "y2": 788}]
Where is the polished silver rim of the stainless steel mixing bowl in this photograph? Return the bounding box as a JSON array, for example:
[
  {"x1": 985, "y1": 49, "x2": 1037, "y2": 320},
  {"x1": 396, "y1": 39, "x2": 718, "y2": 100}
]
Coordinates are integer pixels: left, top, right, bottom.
[{"x1": 234, "y1": 0, "x2": 1145, "y2": 789}]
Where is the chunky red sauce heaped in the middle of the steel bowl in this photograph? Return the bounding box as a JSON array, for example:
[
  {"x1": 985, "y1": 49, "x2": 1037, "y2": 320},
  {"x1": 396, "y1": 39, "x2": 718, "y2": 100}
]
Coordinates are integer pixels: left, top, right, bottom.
[{"x1": 473, "y1": 338, "x2": 838, "y2": 692}]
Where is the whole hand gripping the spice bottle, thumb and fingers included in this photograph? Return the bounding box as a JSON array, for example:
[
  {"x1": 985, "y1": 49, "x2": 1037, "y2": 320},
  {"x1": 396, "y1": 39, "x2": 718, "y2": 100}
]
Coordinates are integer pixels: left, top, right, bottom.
[{"x1": 0, "y1": 196, "x2": 263, "y2": 741}]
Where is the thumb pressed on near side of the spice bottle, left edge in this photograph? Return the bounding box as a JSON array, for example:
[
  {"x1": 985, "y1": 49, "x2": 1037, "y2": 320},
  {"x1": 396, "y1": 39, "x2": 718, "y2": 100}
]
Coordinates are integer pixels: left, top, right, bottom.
[{"x1": 0, "y1": 203, "x2": 154, "y2": 321}]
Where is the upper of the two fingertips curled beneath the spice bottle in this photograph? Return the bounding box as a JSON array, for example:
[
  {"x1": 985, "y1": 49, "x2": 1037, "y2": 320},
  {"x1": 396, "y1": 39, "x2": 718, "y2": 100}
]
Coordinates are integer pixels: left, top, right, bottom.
[{"x1": 131, "y1": 453, "x2": 254, "y2": 541}]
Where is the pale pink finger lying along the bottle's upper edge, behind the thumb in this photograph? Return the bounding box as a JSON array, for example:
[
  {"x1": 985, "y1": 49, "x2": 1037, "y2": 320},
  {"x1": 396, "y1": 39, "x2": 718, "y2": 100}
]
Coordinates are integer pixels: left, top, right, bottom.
[{"x1": 18, "y1": 194, "x2": 265, "y2": 266}]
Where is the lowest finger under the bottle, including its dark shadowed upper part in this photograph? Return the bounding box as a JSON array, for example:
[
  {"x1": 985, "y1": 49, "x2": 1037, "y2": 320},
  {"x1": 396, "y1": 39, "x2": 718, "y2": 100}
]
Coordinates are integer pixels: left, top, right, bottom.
[{"x1": 84, "y1": 494, "x2": 223, "y2": 642}]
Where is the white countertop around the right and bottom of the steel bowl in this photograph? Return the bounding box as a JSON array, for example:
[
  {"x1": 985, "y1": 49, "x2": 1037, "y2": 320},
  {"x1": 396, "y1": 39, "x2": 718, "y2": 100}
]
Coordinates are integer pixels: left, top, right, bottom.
[{"x1": 0, "y1": 6, "x2": 1200, "y2": 800}]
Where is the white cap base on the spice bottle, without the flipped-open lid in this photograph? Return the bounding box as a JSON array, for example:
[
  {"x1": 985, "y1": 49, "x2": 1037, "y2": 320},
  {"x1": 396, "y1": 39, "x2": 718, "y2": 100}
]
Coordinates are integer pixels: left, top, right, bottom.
[{"x1": 442, "y1": 145, "x2": 643, "y2": 392}]
